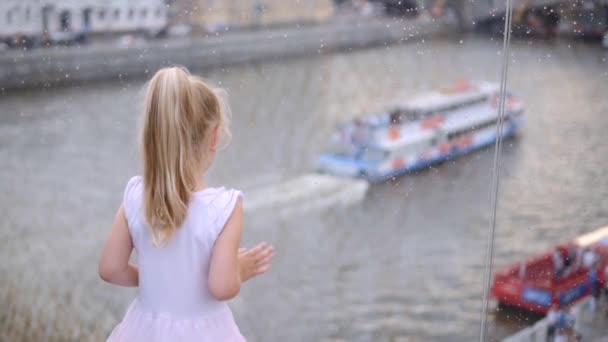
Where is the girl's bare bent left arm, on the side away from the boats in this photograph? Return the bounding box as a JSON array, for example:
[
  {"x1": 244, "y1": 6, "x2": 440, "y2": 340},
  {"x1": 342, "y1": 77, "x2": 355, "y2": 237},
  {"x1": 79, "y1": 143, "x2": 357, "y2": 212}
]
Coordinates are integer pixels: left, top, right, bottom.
[{"x1": 99, "y1": 205, "x2": 139, "y2": 286}]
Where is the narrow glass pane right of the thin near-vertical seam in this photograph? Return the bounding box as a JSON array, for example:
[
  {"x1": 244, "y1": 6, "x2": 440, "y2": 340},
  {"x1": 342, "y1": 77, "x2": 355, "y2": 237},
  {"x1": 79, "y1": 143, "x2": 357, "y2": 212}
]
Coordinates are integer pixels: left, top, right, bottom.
[{"x1": 488, "y1": 1, "x2": 608, "y2": 341}]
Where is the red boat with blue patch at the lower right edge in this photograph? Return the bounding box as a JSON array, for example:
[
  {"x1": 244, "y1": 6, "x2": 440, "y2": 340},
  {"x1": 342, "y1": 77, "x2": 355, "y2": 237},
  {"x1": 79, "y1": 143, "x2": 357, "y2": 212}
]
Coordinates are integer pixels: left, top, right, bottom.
[{"x1": 490, "y1": 227, "x2": 608, "y2": 313}]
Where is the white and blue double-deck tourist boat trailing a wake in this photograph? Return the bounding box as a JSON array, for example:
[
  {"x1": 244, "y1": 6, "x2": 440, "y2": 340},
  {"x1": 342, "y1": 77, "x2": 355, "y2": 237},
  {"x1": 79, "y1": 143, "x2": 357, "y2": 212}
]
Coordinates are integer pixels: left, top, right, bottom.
[{"x1": 317, "y1": 80, "x2": 524, "y2": 181}]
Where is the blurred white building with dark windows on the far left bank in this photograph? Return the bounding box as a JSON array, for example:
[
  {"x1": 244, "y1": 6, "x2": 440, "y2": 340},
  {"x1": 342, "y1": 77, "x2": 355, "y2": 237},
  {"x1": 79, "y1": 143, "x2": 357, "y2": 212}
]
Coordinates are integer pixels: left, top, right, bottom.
[{"x1": 0, "y1": 0, "x2": 167, "y2": 44}]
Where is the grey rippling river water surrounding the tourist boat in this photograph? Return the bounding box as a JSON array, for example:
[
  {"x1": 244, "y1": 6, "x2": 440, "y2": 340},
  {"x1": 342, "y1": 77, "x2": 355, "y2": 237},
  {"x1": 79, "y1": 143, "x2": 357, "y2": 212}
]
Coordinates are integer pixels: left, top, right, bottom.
[{"x1": 0, "y1": 36, "x2": 608, "y2": 341}]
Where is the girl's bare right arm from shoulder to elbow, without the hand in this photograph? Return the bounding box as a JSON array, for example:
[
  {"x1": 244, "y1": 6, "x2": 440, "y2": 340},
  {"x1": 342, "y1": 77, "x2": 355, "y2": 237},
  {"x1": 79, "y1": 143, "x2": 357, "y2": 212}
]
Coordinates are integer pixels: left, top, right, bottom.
[{"x1": 208, "y1": 198, "x2": 243, "y2": 300}]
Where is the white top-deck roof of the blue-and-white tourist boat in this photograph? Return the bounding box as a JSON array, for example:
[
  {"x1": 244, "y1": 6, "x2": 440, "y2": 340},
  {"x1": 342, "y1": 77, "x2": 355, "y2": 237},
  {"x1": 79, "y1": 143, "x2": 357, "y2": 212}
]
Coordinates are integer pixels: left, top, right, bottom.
[{"x1": 397, "y1": 81, "x2": 500, "y2": 111}]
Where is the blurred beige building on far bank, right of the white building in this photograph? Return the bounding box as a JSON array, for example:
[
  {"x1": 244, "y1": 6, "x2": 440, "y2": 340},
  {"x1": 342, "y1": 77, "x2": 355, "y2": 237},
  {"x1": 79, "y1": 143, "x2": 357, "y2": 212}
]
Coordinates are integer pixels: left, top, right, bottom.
[{"x1": 170, "y1": 0, "x2": 334, "y2": 31}]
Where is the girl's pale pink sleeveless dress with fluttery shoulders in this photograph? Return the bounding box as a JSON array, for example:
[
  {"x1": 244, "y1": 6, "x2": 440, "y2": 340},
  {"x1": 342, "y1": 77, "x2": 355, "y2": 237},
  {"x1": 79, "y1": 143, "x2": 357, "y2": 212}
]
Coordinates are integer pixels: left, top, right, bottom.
[{"x1": 108, "y1": 176, "x2": 245, "y2": 342}]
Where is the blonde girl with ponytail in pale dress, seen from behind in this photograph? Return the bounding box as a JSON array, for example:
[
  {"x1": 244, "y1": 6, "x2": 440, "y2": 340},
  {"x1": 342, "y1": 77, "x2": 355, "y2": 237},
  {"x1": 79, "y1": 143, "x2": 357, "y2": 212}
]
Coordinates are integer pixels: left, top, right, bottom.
[{"x1": 99, "y1": 67, "x2": 273, "y2": 341}]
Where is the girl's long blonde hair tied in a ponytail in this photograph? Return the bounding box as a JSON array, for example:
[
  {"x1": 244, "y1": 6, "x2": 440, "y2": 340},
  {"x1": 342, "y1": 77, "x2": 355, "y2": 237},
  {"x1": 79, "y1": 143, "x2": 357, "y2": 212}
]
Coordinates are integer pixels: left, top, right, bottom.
[{"x1": 141, "y1": 66, "x2": 230, "y2": 245}]
